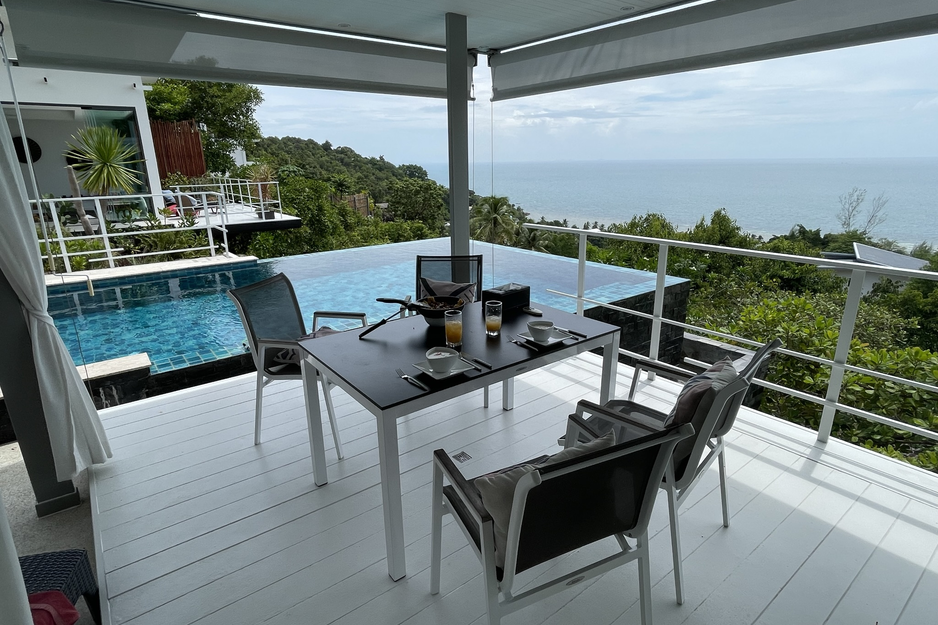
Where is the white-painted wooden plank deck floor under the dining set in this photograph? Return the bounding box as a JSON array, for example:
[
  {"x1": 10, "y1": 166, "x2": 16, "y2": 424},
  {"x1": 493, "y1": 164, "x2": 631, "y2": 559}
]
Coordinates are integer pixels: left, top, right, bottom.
[{"x1": 92, "y1": 354, "x2": 938, "y2": 625}]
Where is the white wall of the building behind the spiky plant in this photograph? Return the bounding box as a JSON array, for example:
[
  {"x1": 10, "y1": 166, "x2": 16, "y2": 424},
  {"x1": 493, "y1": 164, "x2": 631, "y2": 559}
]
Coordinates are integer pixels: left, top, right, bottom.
[{"x1": 0, "y1": 67, "x2": 160, "y2": 196}]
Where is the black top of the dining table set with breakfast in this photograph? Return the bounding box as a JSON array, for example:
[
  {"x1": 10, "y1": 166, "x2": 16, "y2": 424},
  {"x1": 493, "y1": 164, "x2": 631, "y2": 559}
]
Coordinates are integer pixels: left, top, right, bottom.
[{"x1": 300, "y1": 302, "x2": 619, "y2": 410}]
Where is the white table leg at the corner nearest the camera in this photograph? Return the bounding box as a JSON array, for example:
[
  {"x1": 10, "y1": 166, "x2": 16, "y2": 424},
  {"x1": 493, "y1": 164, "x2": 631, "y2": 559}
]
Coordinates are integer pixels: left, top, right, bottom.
[{"x1": 378, "y1": 417, "x2": 407, "y2": 582}]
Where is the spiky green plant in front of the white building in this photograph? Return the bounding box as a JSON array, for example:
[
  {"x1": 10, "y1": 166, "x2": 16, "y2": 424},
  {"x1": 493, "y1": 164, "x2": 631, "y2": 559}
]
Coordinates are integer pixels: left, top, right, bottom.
[{"x1": 65, "y1": 126, "x2": 141, "y2": 195}]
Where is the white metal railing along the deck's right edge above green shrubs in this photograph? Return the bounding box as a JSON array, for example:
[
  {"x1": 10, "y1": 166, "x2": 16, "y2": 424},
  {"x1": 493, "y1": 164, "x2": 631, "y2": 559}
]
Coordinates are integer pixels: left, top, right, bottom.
[{"x1": 523, "y1": 224, "x2": 938, "y2": 443}]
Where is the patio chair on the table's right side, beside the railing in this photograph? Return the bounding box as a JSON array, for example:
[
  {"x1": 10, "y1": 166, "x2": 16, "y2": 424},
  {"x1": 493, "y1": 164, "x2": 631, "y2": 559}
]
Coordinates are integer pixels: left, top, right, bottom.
[{"x1": 564, "y1": 339, "x2": 782, "y2": 604}]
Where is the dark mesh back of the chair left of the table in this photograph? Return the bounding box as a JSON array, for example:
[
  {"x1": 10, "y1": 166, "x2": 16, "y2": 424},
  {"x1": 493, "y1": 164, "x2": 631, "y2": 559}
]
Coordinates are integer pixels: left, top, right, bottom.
[{"x1": 228, "y1": 273, "x2": 306, "y2": 364}]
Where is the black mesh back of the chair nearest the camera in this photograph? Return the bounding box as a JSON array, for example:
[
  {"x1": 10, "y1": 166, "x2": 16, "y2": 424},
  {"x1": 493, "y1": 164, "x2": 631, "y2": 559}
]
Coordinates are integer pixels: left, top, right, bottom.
[{"x1": 509, "y1": 425, "x2": 693, "y2": 573}]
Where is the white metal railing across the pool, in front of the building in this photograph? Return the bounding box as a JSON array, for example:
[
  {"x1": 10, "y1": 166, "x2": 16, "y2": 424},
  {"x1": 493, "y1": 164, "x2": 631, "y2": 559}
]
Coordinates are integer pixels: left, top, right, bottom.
[{"x1": 30, "y1": 192, "x2": 228, "y2": 273}]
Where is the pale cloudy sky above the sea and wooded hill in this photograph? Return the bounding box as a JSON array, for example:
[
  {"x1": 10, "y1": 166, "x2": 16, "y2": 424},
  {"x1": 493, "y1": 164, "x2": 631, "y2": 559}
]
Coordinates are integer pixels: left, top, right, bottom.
[{"x1": 250, "y1": 35, "x2": 938, "y2": 164}]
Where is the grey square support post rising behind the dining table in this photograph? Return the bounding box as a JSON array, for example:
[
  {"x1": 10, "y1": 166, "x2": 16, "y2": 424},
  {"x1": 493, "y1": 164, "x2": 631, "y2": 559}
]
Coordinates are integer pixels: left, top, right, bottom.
[{"x1": 446, "y1": 13, "x2": 471, "y2": 256}]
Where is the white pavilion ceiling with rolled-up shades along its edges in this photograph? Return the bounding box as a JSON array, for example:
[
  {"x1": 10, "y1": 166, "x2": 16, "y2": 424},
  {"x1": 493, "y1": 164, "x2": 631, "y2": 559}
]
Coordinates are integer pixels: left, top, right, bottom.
[{"x1": 2, "y1": 0, "x2": 938, "y2": 99}]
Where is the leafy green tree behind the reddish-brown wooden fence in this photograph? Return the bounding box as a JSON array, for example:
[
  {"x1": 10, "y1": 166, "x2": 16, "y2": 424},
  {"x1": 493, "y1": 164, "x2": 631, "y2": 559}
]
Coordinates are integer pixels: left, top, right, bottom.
[{"x1": 146, "y1": 78, "x2": 264, "y2": 173}]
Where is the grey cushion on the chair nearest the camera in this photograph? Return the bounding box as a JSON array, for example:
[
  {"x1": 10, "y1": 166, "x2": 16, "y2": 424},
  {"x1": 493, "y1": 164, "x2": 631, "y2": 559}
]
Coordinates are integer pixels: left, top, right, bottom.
[{"x1": 474, "y1": 431, "x2": 616, "y2": 568}]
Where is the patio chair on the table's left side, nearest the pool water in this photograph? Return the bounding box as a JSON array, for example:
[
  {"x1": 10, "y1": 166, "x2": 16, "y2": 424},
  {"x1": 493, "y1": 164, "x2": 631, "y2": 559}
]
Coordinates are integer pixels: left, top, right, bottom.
[{"x1": 228, "y1": 273, "x2": 368, "y2": 459}]
